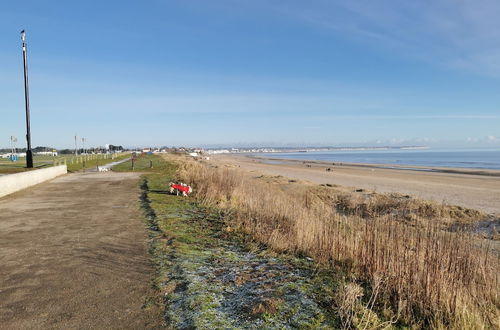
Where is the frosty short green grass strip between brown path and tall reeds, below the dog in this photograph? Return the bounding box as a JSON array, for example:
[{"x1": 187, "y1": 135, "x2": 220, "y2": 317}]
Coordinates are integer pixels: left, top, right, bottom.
[{"x1": 150, "y1": 193, "x2": 332, "y2": 329}]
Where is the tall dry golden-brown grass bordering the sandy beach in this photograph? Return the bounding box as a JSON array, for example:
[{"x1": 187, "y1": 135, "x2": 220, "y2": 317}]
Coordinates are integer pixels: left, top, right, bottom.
[{"x1": 178, "y1": 162, "x2": 500, "y2": 329}]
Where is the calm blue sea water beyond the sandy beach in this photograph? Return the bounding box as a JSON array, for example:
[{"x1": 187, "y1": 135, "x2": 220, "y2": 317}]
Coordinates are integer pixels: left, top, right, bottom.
[{"x1": 264, "y1": 149, "x2": 500, "y2": 169}]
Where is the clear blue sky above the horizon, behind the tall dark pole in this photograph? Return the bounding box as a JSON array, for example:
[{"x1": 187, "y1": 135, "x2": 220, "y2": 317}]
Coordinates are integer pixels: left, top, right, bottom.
[{"x1": 0, "y1": 0, "x2": 500, "y2": 147}]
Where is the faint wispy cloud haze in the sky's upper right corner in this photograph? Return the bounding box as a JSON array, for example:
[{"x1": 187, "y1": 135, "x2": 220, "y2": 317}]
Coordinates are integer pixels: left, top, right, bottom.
[{"x1": 268, "y1": 0, "x2": 500, "y2": 76}]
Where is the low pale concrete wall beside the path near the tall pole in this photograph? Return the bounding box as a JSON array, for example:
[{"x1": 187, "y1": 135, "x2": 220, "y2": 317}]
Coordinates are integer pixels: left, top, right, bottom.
[{"x1": 0, "y1": 165, "x2": 68, "y2": 197}]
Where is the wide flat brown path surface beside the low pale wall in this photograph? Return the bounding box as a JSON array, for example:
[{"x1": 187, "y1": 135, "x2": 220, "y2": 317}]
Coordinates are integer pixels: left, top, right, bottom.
[{"x1": 0, "y1": 172, "x2": 161, "y2": 329}]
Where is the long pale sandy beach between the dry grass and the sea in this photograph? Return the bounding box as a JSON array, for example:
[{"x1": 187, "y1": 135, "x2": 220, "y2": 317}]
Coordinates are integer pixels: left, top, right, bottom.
[{"x1": 210, "y1": 154, "x2": 500, "y2": 215}]
